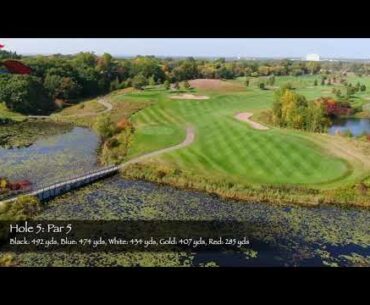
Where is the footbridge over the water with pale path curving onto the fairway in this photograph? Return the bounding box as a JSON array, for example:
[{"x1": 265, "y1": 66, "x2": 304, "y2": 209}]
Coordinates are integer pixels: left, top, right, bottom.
[{"x1": 0, "y1": 127, "x2": 195, "y2": 204}]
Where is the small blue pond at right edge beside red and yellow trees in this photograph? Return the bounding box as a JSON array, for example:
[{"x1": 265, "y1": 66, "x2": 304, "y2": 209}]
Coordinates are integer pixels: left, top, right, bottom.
[{"x1": 328, "y1": 118, "x2": 370, "y2": 136}]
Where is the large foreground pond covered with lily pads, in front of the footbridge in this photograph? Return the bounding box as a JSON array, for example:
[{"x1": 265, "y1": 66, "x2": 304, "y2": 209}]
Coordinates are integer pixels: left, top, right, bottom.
[{"x1": 12, "y1": 175, "x2": 370, "y2": 266}]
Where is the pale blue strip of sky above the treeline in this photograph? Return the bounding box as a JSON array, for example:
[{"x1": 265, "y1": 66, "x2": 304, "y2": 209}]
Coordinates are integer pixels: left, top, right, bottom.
[{"x1": 0, "y1": 38, "x2": 370, "y2": 59}]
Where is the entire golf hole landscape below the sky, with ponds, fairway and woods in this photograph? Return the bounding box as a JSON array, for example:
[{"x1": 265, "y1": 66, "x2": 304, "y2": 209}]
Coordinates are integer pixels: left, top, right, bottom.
[{"x1": 0, "y1": 39, "x2": 370, "y2": 267}]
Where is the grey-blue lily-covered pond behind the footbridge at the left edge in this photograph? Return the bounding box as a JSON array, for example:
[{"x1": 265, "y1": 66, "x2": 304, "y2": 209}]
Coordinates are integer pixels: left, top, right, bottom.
[{"x1": 0, "y1": 127, "x2": 100, "y2": 187}]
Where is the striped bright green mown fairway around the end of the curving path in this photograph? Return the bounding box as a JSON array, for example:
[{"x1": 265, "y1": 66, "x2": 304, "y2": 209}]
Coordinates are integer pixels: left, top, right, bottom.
[{"x1": 125, "y1": 78, "x2": 362, "y2": 185}]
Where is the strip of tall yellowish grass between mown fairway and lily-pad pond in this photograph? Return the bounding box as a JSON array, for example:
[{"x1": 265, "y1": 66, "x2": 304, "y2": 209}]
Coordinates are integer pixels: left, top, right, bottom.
[{"x1": 122, "y1": 161, "x2": 370, "y2": 208}]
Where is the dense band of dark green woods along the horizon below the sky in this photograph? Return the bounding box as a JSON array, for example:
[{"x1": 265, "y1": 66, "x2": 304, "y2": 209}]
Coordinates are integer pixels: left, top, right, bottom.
[{"x1": 0, "y1": 51, "x2": 370, "y2": 114}]
